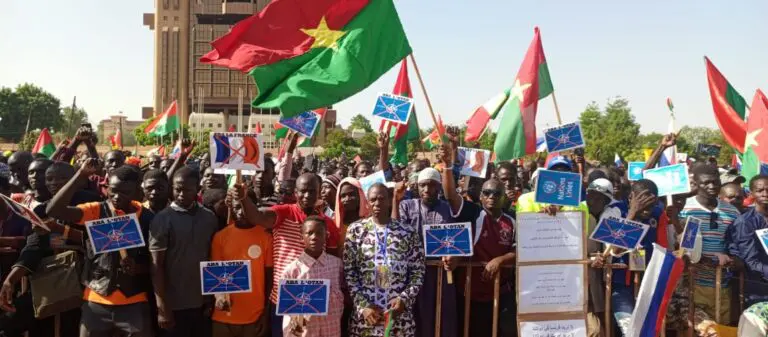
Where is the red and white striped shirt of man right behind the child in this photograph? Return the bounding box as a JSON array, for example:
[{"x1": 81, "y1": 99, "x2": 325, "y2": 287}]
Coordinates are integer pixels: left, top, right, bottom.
[{"x1": 269, "y1": 204, "x2": 339, "y2": 303}]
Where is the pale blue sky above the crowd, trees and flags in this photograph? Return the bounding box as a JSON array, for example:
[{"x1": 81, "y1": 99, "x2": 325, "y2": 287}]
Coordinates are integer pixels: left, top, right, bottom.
[{"x1": 0, "y1": 0, "x2": 768, "y2": 132}]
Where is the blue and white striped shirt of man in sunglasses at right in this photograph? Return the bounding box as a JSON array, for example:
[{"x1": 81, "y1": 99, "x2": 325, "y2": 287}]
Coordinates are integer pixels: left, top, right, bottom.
[{"x1": 680, "y1": 196, "x2": 740, "y2": 288}]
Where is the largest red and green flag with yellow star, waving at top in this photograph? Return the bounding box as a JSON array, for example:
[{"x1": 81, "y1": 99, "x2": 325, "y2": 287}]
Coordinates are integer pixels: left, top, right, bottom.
[{"x1": 200, "y1": 0, "x2": 411, "y2": 117}]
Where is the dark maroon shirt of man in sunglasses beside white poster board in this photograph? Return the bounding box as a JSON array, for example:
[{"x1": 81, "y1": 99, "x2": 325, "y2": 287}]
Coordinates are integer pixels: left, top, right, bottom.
[{"x1": 461, "y1": 210, "x2": 515, "y2": 302}]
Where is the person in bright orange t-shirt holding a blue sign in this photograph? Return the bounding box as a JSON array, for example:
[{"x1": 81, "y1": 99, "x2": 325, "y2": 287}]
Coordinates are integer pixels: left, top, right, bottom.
[{"x1": 211, "y1": 194, "x2": 272, "y2": 337}]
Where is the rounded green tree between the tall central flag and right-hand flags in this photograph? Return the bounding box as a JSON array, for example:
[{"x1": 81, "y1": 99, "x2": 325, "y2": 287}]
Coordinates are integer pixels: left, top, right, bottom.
[{"x1": 579, "y1": 97, "x2": 640, "y2": 163}]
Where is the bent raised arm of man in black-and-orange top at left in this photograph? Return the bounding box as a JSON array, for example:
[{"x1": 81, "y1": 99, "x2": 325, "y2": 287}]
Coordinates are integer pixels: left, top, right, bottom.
[{"x1": 45, "y1": 158, "x2": 101, "y2": 223}]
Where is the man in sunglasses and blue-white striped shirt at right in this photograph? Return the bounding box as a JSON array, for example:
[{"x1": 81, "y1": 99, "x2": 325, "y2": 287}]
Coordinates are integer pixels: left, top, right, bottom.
[{"x1": 680, "y1": 164, "x2": 739, "y2": 324}]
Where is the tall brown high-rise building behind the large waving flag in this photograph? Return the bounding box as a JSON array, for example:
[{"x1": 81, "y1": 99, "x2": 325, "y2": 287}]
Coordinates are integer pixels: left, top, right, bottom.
[{"x1": 142, "y1": 0, "x2": 336, "y2": 148}]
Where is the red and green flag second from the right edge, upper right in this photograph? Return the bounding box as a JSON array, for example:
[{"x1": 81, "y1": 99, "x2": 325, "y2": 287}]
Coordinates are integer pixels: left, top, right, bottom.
[{"x1": 704, "y1": 57, "x2": 747, "y2": 153}]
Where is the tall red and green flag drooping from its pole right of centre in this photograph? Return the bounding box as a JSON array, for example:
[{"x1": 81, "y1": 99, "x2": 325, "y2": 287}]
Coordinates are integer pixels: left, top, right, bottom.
[{"x1": 493, "y1": 27, "x2": 554, "y2": 161}]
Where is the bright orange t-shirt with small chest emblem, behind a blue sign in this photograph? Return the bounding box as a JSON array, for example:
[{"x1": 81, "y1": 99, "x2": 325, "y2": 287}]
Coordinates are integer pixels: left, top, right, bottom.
[{"x1": 211, "y1": 225, "x2": 272, "y2": 325}]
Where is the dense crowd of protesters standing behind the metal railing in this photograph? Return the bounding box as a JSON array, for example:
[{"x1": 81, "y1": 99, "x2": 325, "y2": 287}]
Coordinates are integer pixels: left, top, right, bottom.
[{"x1": 0, "y1": 129, "x2": 768, "y2": 337}]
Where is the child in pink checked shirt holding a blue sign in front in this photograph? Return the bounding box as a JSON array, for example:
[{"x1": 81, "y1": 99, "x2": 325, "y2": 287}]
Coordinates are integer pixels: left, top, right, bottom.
[{"x1": 282, "y1": 216, "x2": 344, "y2": 337}]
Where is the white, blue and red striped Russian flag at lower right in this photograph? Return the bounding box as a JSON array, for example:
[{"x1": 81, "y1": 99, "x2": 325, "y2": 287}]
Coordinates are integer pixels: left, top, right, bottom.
[{"x1": 627, "y1": 243, "x2": 684, "y2": 337}]
